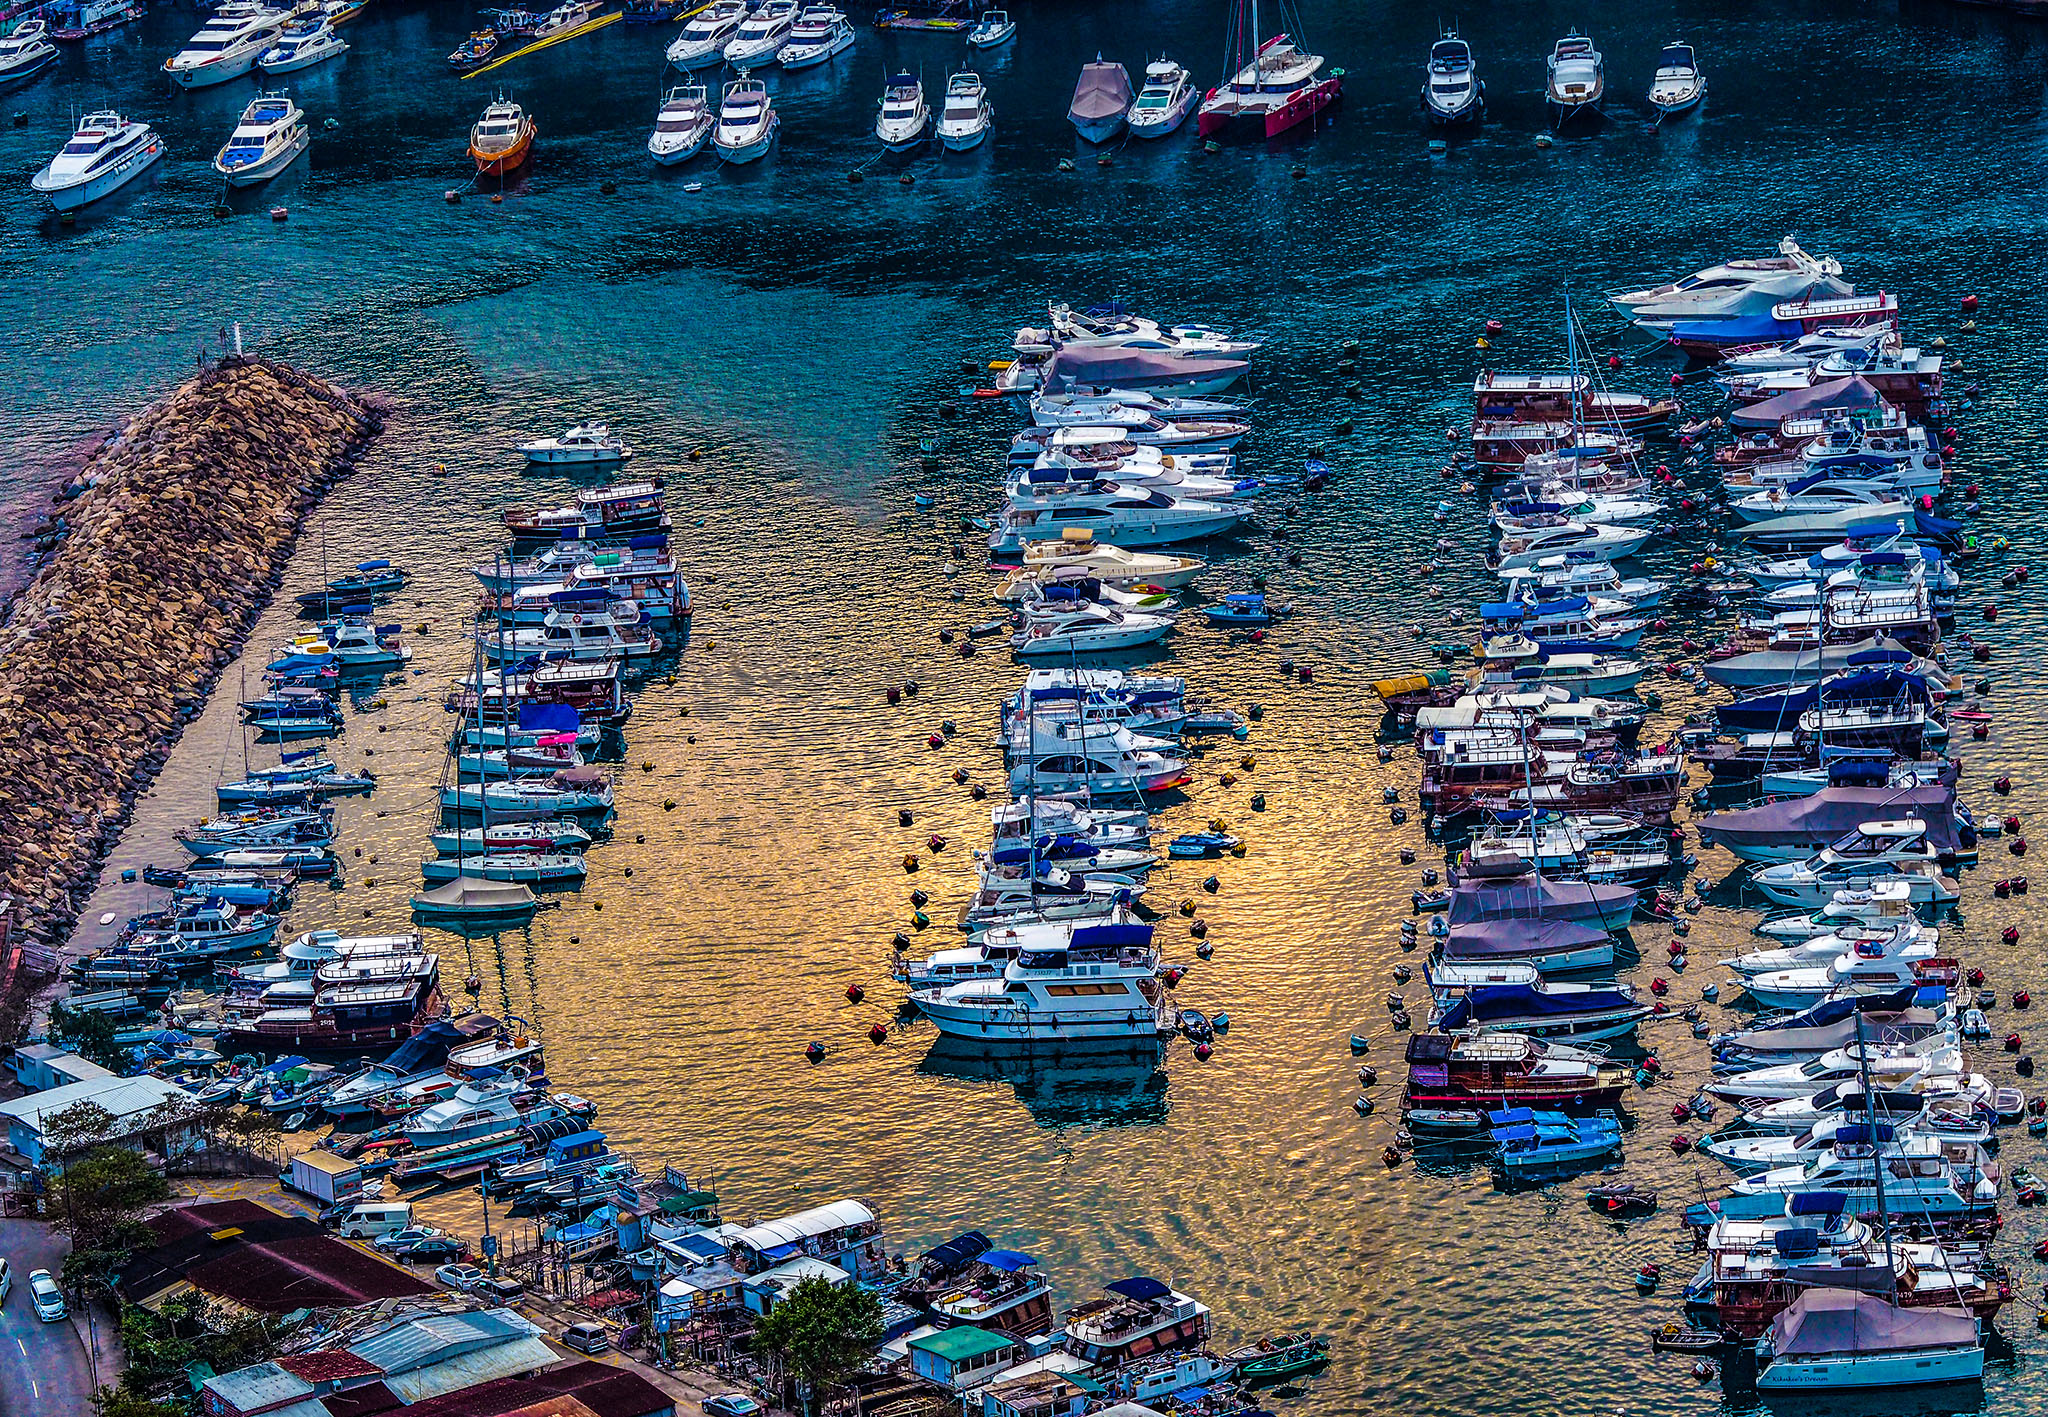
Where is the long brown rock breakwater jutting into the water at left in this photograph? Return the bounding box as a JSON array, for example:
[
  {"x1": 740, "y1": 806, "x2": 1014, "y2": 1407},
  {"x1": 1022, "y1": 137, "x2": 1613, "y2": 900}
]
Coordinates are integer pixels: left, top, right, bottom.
[{"x1": 0, "y1": 358, "x2": 383, "y2": 986}]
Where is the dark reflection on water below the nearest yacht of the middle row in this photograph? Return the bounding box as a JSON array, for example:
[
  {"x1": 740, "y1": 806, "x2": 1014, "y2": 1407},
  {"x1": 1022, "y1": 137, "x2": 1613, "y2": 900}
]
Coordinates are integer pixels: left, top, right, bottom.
[{"x1": 918, "y1": 1034, "x2": 1165, "y2": 1126}]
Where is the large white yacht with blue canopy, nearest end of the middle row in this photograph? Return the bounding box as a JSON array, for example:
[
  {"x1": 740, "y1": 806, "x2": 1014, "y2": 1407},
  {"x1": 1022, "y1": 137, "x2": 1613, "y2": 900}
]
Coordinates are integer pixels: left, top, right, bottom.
[{"x1": 911, "y1": 942, "x2": 1176, "y2": 1042}]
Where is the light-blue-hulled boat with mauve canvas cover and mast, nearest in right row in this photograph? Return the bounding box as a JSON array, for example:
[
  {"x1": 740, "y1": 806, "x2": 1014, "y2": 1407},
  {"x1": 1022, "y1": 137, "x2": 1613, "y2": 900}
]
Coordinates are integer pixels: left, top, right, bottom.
[{"x1": 1757, "y1": 1016, "x2": 1985, "y2": 1392}]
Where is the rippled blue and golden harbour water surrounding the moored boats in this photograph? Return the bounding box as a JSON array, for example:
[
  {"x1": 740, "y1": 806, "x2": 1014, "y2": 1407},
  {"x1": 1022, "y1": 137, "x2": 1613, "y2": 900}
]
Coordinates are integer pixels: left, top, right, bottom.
[{"x1": 12, "y1": 0, "x2": 2048, "y2": 1413}]
